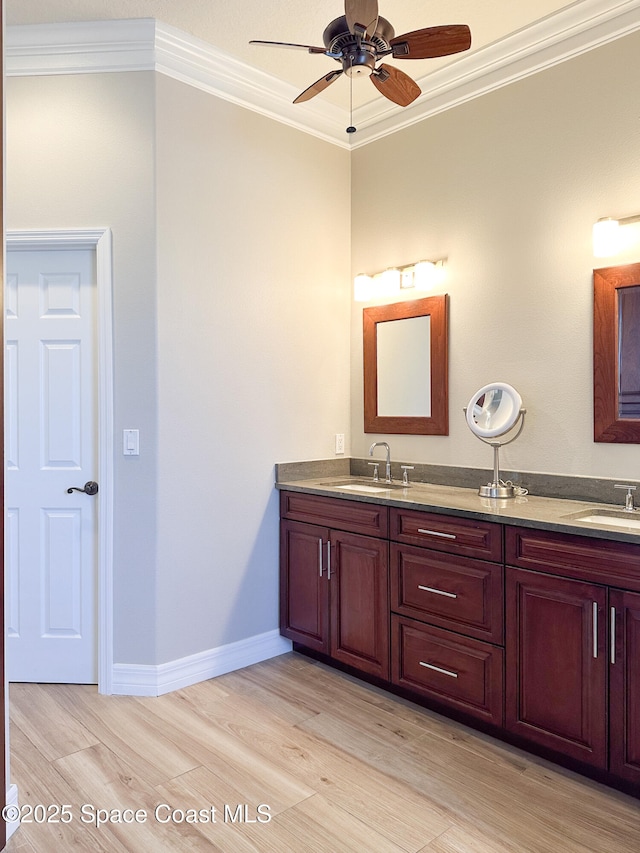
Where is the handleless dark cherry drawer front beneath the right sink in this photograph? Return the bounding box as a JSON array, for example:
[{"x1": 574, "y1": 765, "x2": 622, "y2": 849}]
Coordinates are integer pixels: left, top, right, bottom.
[{"x1": 505, "y1": 526, "x2": 640, "y2": 592}]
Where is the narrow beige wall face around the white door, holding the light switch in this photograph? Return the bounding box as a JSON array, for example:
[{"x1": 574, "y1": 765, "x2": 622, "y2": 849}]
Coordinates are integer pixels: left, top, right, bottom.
[{"x1": 5, "y1": 73, "x2": 157, "y2": 663}]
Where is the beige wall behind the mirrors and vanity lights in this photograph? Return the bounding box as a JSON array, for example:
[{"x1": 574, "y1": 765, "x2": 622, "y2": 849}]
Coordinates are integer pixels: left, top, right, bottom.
[{"x1": 352, "y1": 35, "x2": 640, "y2": 486}]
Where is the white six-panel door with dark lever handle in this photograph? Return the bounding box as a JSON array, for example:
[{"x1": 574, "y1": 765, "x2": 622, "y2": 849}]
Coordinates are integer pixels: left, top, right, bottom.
[{"x1": 5, "y1": 248, "x2": 99, "y2": 684}]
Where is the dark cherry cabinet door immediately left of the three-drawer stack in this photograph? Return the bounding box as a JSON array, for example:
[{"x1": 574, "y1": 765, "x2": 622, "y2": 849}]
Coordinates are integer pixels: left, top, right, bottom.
[{"x1": 329, "y1": 530, "x2": 389, "y2": 680}]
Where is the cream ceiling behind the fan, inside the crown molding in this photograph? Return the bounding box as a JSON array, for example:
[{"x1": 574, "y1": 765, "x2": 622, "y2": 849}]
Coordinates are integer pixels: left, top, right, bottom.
[{"x1": 5, "y1": 0, "x2": 585, "y2": 110}]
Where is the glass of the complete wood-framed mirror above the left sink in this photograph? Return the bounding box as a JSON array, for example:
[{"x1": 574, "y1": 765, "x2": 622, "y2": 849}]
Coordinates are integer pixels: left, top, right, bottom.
[{"x1": 376, "y1": 315, "x2": 431, "y2": 418}]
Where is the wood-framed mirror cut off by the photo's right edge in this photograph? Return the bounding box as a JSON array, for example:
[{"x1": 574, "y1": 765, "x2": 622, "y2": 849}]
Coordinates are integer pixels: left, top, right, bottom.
[{"x1": 593, "y1": 263, "x2": 640, "y2": 444}]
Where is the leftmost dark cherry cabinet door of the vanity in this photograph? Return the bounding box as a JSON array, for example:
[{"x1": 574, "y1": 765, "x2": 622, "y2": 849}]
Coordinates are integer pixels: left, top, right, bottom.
[{"x1": 280, "y1": 521, "x2": 329, "y2": 653}]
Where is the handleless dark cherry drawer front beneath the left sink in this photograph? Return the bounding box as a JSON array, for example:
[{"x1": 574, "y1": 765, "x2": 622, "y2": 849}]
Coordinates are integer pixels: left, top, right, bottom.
[{"x1": 280, "y1": 491, "x2": 389, "y2": 539}]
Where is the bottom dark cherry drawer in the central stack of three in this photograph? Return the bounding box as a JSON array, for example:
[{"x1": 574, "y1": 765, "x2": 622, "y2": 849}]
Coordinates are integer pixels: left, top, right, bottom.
[{"x1": 391, "y1": 616, "x2": 504, "y2": 725}]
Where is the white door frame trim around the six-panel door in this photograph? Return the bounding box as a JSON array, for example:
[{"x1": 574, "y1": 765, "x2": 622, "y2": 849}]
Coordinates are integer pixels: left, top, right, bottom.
[{"x1": 6, "y1": 228, "x2": 114, "y2": 694}]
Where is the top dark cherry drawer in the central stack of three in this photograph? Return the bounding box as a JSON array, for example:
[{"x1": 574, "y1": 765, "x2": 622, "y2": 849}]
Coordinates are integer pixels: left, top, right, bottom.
[{"x1": 390, "y1": 508, "x2": 502, "y2": 563}]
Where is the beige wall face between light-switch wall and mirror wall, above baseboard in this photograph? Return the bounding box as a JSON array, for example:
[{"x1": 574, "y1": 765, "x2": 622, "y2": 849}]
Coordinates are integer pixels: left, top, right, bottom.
[{"x1": 157, "y1": 76, "x2": 350, "y2": 661}]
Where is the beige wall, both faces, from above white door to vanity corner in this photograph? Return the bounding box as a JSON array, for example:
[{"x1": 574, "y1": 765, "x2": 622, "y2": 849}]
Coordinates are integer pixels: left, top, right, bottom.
[{"x1": 6, "y1": 72, "x2": 350, "y2": 664}]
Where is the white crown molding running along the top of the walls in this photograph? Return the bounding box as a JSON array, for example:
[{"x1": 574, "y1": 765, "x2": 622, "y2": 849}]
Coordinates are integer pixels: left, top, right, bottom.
[{"x1": 5, "y1": 0, "x2": 640, "y2": 149}]
